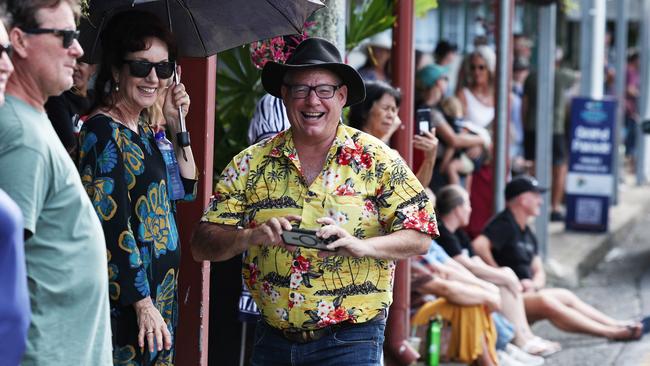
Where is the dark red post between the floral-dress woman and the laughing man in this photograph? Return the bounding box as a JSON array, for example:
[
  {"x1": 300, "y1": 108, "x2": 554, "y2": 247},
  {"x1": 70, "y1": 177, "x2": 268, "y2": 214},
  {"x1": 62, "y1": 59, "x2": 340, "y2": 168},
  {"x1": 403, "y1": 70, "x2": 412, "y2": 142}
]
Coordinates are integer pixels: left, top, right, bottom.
[{"x1": 176, "y1": 56, "x2": 217, "y2": 366}]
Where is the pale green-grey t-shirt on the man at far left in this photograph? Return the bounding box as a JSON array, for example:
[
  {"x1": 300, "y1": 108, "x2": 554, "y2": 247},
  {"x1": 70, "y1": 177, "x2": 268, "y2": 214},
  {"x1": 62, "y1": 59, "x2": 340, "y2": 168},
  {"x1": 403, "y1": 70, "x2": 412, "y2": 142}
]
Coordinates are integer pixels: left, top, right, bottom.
[{"x1": 0, "y1": 95, "x2": 112, "y2": 366}]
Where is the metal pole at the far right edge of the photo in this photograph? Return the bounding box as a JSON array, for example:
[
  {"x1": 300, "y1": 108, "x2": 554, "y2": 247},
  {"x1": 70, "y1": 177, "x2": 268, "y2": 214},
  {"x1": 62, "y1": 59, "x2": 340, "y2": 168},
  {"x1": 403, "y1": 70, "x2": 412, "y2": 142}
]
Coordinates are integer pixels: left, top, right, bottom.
[{"x1": 636, "y1": 0, "x2": 650, "y2": 185}]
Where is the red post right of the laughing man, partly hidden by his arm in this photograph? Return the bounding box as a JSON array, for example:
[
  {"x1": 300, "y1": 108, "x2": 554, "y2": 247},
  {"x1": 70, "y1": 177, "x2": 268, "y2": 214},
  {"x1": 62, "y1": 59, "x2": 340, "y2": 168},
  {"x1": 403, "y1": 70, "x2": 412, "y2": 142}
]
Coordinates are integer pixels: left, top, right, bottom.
[{"x1": 384, "y1": 0, "x2": 420, "y2": 365}]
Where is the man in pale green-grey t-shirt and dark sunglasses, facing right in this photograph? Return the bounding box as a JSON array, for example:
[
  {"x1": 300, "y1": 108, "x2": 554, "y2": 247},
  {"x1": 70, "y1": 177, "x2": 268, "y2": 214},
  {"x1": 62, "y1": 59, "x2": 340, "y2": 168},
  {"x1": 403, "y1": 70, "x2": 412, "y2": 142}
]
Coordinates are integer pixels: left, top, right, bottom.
[{"x1": 0, "y1": 0, "x2": 112, "y2": 365}]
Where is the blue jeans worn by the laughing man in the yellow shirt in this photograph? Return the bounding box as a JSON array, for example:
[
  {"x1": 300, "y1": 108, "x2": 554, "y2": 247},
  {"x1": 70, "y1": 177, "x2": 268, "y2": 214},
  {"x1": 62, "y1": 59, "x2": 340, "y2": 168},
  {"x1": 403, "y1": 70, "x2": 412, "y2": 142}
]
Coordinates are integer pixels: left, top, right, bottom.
[{"x1": 251, "y1": 319, "x2": 386, "y2": 366}]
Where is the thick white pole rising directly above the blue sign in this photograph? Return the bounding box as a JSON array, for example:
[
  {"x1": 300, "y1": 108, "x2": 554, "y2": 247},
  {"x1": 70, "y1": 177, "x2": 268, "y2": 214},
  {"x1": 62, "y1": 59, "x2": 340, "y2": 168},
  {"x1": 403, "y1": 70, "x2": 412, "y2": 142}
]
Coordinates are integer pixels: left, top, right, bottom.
[{"x1": 580, "y1": 0, "x2": 605, "y2": 99}]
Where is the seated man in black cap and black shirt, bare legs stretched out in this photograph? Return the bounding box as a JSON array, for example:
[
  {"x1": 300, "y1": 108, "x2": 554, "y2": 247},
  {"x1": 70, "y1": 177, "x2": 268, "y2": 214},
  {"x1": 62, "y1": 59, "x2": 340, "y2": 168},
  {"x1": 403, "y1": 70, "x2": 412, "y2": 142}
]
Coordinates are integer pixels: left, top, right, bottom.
[{"x1": 472, "y1": 176, "x2": 643, "y2": 340}]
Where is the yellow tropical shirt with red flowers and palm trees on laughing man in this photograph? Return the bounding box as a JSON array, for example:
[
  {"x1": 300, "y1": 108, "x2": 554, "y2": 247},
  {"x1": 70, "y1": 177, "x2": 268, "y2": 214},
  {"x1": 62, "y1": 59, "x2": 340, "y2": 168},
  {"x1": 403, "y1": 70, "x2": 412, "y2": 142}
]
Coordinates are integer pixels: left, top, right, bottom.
[{"x1": 202, "y1": 124, "x2": 438, "y2": 329}]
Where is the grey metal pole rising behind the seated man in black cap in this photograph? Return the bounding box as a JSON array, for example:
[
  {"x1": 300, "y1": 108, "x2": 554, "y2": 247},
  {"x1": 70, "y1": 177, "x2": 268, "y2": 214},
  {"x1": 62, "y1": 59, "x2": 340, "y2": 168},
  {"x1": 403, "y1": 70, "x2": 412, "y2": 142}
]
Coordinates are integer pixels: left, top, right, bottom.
[{"x1": 535, "y1": 4, "x2": 557, "y2": 260}]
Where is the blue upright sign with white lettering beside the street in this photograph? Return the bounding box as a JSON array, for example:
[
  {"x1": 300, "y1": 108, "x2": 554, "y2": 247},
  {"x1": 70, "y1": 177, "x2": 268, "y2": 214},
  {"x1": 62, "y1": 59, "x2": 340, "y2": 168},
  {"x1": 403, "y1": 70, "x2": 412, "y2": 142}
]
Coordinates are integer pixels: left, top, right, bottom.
[{"x1": 566, "y1": 98, "x2": 616, "y2": 231}]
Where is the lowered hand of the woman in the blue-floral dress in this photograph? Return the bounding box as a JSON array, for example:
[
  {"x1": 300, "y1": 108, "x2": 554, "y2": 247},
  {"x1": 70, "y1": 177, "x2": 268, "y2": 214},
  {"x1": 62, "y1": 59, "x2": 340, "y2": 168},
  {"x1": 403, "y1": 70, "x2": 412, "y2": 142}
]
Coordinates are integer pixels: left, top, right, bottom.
[{"x1": 133, "y1": 297, "x2": 172, "y2": 353}]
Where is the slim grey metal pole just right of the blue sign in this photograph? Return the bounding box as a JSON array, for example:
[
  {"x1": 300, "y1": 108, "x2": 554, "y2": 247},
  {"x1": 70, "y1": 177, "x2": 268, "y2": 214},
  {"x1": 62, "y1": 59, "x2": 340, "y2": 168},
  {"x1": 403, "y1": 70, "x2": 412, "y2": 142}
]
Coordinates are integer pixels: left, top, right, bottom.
[{"x1": 611, "y1": 0, "x2": 629, "y2": 205}]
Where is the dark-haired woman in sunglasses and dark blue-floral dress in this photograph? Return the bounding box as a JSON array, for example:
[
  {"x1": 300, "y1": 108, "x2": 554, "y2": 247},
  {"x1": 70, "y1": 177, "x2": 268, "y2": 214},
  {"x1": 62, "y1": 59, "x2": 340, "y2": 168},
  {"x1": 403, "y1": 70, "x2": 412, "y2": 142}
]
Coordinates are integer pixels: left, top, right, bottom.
[{"x1": 79, "y1": 11, "x2": 197, "y2": 365}]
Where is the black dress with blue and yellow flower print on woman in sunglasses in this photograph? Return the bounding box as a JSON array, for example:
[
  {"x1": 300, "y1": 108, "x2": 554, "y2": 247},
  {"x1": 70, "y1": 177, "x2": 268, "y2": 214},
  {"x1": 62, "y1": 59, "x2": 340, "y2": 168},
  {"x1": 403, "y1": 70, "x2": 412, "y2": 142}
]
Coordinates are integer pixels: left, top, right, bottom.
[{"x1": 79, "y1": 114, "x2": 196, "y2": 365}]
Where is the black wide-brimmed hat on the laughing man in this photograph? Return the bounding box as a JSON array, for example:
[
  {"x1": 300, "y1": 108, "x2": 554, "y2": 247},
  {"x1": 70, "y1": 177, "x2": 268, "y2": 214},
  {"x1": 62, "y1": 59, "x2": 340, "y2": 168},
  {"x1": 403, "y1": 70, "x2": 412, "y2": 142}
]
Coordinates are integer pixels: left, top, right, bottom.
[{"x1": 262, "y1": 37, "x2": 366, "y2": 107}]
